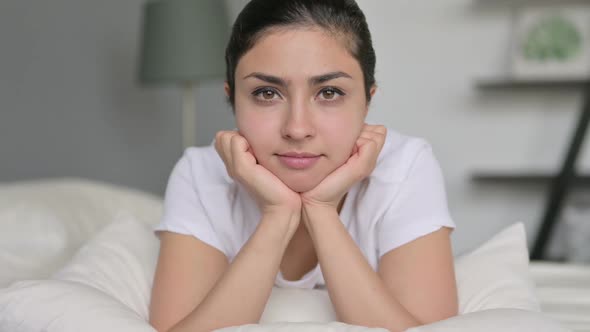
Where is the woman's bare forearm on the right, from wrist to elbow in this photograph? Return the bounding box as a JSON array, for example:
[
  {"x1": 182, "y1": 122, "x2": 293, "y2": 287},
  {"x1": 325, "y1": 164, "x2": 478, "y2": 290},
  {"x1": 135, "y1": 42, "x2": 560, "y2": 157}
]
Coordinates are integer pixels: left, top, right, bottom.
[{"x1": 303, "y1": 208, "x2": 420, "y2": 332}]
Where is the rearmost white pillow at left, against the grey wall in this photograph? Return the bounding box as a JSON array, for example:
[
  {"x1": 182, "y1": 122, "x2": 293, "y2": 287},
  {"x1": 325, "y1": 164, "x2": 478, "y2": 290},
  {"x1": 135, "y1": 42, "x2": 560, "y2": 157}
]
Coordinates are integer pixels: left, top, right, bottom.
[{"x1": 0, "y1": 178, "x2": 162, "y2": 287}]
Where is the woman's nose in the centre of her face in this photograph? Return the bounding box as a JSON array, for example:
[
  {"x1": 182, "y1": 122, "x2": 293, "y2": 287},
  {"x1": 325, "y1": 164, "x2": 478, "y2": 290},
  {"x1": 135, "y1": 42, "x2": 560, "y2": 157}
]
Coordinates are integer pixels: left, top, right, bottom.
[{"x1": 281, "y1": 101, "x2": 315, "y2": 141}]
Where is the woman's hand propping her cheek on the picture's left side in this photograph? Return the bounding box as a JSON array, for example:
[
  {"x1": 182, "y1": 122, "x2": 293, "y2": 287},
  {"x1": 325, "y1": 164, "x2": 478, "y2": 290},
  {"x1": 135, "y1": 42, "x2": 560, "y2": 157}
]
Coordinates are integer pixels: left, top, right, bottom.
[{"x1": 215, "y1": 131, "x2": 301, "y2": 214}]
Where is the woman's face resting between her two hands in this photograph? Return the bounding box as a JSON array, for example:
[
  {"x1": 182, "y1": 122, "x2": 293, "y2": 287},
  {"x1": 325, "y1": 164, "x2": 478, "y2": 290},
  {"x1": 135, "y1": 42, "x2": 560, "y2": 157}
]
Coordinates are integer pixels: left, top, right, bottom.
[{"x1": 226, "y1": 28, "x2": 374, "y2": 192}]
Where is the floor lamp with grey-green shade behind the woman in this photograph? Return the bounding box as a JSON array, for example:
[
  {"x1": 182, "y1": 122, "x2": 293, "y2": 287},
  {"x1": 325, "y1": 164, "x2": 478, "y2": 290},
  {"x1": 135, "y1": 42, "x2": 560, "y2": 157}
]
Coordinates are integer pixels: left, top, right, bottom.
[{"x1": 139, "y1": 0, "x2": 229, "y2": 148}]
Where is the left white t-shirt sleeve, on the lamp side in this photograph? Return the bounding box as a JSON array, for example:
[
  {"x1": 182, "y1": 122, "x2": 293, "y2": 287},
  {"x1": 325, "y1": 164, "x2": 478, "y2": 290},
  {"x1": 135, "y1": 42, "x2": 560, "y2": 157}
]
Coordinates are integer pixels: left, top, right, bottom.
[{"x1": 154, "y1": 151, "x2": 228, "y2": 256}]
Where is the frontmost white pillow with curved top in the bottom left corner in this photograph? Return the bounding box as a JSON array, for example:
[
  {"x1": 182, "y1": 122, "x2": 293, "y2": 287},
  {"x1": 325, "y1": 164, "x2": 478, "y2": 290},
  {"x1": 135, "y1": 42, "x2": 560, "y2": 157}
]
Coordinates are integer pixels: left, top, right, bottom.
[{"x1": 0, "y1": 280, "x2": 156, "y2": 332}]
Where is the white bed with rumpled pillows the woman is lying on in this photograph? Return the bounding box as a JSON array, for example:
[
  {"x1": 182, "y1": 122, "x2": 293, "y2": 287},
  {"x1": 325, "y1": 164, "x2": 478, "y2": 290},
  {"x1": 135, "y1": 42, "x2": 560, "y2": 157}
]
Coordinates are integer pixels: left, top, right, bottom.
[{"x1": 0, "y1": 178, "x2": 590, "y2": 332}]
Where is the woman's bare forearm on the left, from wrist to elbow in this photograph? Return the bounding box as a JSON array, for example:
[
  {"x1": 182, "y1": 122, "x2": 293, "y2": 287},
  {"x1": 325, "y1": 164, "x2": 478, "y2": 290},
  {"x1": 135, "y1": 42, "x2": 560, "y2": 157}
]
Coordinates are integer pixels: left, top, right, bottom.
[{"x1": 171, "y1": 213, "x2": 299, "y2": 332}]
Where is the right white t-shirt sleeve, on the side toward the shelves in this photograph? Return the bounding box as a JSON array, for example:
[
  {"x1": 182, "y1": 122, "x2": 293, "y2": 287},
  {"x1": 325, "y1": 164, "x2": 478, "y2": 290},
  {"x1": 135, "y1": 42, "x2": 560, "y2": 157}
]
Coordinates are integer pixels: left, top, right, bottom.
[{"x1": 377, "y1": 145, "x2": 455, "y2": 258}]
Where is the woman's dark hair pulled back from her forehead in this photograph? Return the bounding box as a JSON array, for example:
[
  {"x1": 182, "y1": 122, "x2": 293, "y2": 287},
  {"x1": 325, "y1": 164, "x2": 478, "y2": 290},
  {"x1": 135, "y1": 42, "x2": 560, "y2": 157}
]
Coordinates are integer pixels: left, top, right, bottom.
[{"x1": 225, "y1": 0, "x2": 376, "y2": 108}]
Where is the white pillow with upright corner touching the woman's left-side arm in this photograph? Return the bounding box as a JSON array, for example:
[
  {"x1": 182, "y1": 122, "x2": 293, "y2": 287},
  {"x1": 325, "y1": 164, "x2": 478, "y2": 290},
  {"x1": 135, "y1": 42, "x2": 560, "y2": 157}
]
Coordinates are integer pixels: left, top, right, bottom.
[{"x1": 52, "y1": 212, "x2": 160, "y2": 320}]
